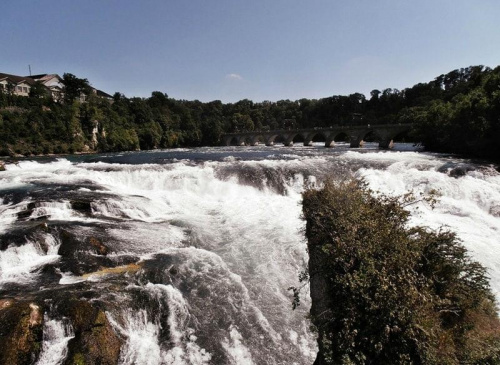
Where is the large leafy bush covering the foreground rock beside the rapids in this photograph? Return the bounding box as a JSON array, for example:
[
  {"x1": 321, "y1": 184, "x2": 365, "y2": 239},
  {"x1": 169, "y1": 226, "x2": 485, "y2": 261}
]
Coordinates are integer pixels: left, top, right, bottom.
[{"x1": 303, "y1": 181, "x2": 500, "y2": 364}]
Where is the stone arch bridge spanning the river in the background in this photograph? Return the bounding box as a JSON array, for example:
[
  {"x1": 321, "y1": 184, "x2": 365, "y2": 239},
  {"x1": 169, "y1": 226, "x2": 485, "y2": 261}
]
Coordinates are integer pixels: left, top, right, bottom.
[{"x1": 222, "y1": 124, "x2": 412, "y2": 148}]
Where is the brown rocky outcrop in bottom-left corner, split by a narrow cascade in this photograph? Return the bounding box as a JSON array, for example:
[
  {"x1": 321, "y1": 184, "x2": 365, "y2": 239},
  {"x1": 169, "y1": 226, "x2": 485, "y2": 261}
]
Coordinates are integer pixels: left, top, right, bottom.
[{"x1": 0, "y1": 291, "x2": 127, "y2": 365}]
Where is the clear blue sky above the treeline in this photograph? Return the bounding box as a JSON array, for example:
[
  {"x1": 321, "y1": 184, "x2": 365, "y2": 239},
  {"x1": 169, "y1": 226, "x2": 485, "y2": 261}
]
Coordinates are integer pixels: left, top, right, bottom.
[{"x1": 0, "y1": 0, "x2": 500, "y2": 102}]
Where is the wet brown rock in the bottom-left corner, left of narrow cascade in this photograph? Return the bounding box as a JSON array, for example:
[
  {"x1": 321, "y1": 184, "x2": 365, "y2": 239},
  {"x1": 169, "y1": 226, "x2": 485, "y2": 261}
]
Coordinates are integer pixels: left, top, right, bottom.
[{"x1": 0, "y1": 299, "x2": 43, "y2": 365}]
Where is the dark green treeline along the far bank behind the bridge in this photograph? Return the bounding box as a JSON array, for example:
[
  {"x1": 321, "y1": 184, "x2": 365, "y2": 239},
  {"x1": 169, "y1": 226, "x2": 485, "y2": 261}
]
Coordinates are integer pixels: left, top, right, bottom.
[{"x1": 0, "y1": 66, "x2": 500, "y2": 159}]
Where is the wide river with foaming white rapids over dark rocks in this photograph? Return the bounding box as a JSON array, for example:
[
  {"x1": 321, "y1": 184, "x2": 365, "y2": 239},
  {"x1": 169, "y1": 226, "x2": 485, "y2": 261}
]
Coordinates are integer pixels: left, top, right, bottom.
[{"x1": 0, "y1": 144, "x2": 500, "y2": 364}]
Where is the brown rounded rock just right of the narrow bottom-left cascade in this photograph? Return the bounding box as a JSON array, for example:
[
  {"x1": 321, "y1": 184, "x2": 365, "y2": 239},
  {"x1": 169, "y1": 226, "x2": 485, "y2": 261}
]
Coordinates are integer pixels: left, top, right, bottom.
[{"x1": 64, "y1": 300, "x2": 123, "y2": 365}]
